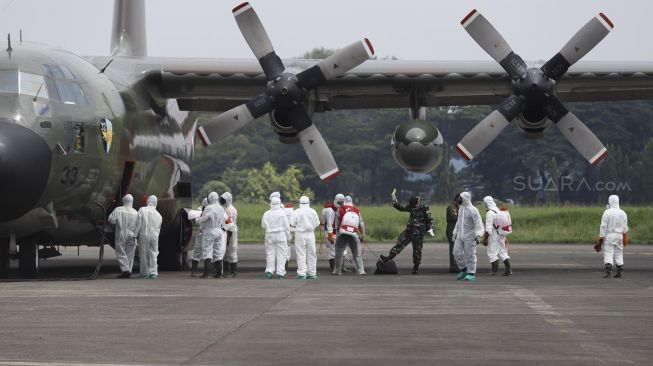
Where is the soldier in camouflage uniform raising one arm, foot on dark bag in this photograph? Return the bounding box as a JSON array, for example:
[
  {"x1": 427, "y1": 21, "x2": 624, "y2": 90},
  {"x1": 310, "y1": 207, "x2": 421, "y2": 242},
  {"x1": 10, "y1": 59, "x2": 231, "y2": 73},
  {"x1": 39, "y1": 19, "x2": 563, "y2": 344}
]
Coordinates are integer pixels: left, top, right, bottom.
[{"x1": 381, "y1": 192, "x2": 435, "y2": 274}]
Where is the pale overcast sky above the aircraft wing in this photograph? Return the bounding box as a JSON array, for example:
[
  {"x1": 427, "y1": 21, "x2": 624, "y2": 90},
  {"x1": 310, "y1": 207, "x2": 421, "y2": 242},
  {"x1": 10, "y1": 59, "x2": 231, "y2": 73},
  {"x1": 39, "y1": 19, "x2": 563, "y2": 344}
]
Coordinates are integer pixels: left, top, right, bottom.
[{"x1": 0, "y1": 0, "x2": 653, "y2": 61}]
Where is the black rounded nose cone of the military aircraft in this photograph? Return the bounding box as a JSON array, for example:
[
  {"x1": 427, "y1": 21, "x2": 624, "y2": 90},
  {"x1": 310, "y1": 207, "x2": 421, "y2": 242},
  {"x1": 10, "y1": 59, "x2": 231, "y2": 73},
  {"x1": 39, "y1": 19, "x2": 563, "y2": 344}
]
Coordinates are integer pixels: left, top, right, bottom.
[{"x1": 0, "y1": 122, "x2": 52, "y2": 222}]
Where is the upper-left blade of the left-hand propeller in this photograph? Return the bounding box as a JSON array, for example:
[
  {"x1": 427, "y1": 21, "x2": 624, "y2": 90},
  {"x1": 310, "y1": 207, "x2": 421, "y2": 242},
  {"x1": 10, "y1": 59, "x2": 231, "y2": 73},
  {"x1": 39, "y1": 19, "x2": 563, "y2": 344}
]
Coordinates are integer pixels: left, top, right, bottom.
[{"x1": 233, "y1": 3, "x2": 286, "y2": 80}]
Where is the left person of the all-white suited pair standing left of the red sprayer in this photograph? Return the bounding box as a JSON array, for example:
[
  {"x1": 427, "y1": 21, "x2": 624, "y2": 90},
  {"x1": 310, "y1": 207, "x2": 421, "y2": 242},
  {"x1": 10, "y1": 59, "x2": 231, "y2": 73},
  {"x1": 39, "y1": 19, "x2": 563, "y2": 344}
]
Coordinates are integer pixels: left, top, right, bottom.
[{"x1": 261, "y1": 197, "x2": 290, "y2": 279}]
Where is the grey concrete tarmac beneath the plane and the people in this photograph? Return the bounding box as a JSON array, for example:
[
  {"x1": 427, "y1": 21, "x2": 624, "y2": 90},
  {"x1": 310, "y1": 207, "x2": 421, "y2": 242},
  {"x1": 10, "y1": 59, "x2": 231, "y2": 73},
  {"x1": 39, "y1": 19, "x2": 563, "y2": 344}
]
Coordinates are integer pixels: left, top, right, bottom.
[{"x1": 0, "y1": 244, "x2": 653, "y2": 366}]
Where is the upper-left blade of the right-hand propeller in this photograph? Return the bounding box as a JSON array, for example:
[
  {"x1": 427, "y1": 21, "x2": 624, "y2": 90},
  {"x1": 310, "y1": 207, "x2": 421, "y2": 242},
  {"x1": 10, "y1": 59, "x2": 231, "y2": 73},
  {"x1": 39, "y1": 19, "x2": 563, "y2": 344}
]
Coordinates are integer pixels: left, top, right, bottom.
[{"x1": 460, "y1": 9, "x2": 527, "y2": 80}]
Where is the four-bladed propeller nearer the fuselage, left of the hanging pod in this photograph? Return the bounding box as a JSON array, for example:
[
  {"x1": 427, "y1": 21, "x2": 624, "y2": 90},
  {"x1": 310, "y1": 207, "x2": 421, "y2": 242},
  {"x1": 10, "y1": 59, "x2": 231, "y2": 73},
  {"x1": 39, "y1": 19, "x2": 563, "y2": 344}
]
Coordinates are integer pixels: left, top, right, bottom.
[{"x1": 197, "y1": 3, "x2": 374, "y2": 181}]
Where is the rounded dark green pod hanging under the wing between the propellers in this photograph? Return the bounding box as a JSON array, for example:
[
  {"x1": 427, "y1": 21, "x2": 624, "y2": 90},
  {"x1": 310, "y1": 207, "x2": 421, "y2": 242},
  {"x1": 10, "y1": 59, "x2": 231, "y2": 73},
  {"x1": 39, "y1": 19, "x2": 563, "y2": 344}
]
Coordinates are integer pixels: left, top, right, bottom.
[{"x1": 390, "y1": 119, "x2": 445, "y2": 173}]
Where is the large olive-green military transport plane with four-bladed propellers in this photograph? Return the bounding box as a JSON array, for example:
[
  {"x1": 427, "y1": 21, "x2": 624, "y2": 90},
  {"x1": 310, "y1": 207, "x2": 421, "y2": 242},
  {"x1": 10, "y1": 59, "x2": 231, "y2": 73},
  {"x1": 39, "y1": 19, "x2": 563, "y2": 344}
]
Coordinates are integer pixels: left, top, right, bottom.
[{"x1": 0, "y1": 0, "x2": 653, "y2": 277}]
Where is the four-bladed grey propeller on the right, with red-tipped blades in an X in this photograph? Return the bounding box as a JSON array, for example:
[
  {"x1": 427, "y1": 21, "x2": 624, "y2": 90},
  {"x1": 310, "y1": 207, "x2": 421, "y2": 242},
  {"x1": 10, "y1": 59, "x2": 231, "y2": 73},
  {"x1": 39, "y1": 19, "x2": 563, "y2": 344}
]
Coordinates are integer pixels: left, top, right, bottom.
[{"x1": 456, "y1": 10, "x2": 614, "y2": 164}]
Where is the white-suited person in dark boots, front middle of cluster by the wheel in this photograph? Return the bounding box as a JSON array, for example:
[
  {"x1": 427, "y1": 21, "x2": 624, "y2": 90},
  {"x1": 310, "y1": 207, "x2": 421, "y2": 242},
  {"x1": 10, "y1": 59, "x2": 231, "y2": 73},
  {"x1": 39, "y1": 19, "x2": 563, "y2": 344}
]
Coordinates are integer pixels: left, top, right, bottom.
[{"x1": 199, "y1": 192, "x2": 225, "y2": 278}]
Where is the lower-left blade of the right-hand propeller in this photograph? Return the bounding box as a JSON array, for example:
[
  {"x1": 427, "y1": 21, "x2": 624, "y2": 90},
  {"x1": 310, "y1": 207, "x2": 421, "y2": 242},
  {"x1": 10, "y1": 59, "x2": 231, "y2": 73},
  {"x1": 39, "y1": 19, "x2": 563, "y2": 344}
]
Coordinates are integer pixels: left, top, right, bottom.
[{"x1": 456, "y1": 95, "x2": 524, "y2": 160}]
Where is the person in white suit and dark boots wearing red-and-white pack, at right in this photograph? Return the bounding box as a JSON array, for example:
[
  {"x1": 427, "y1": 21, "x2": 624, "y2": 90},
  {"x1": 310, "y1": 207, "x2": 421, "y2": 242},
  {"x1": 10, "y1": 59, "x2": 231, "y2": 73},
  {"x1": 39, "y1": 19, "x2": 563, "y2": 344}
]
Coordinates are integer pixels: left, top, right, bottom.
[{"x1": 483, "y1": 196, "x2": 512, "y2": 276}]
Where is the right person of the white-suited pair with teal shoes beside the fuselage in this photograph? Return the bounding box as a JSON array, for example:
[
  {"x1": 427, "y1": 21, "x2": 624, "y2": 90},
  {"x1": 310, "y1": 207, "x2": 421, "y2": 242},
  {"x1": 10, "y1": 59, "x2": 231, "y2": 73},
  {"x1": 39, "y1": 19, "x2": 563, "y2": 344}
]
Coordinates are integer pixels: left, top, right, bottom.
[{"x1": 135, "y1": 195, "x2": 163, "y2": 279}]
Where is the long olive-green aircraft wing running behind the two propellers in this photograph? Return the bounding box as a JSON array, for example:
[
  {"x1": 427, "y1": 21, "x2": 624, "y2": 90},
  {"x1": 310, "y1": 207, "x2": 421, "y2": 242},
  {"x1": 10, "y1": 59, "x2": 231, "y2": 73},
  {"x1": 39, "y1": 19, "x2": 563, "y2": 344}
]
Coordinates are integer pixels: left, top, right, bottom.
[{"x1": 132, "y1": 58, "x2": 653, "y2": 112}]
